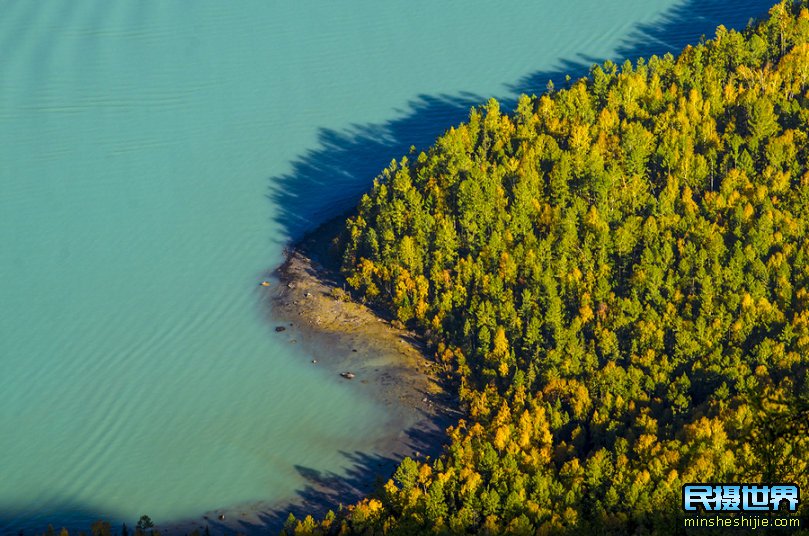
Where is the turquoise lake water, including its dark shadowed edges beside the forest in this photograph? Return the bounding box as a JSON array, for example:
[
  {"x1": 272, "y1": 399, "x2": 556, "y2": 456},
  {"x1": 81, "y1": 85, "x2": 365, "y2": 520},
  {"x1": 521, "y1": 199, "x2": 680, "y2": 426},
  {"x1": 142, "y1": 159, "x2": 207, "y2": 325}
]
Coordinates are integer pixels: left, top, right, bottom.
[{"x1": 0, "y1": 0, "x2": 770, "y2": 533}]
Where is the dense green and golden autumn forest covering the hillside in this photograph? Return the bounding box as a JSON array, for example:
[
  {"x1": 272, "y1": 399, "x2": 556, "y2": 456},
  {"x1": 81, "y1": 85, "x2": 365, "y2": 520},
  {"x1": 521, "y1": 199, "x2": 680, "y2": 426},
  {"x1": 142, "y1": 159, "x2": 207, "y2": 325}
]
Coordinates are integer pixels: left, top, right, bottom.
[{"x1": 287, "y1": 0, "x2": 809, "y2": 534}]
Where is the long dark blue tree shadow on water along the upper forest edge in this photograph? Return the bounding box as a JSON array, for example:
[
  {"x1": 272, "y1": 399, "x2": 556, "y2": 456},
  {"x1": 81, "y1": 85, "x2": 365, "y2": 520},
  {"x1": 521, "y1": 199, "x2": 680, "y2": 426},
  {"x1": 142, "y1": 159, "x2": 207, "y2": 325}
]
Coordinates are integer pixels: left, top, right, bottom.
[{"x1": 267, "y1": 0, "x2": 774, "y2": 242}]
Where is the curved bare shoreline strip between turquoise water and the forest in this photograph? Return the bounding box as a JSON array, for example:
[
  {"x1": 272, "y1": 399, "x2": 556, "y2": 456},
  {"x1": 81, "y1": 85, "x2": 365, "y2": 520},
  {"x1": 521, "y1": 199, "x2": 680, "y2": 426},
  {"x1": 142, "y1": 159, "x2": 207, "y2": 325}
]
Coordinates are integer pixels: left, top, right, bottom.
[{"x1": 158, "y1": 218, "x2": 459, "y2": 535}]
